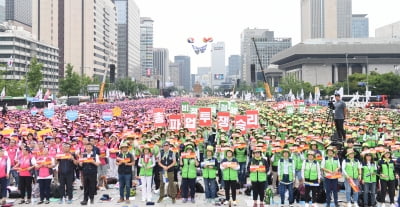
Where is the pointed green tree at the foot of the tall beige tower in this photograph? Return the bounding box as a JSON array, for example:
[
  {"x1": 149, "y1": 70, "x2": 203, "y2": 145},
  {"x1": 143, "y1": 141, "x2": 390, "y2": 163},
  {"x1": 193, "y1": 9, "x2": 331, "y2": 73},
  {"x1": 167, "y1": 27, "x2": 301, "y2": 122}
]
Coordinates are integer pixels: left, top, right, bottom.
[{"x1": 59, "y1": 63, "x2": 81, "y2": 96}]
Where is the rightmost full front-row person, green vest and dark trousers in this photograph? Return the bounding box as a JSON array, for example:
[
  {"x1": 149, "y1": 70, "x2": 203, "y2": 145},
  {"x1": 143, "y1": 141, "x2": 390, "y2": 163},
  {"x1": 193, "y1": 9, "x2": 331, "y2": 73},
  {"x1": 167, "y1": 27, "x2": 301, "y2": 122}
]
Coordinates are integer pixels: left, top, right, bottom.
[{"x1": 378, "y1": 150, "x2": 396, "y2": 206}]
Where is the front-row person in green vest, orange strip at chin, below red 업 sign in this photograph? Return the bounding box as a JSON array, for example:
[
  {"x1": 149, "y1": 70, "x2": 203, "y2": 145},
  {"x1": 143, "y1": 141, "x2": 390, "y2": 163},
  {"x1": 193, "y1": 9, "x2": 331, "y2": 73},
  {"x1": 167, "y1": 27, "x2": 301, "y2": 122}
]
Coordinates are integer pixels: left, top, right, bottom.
[{"x1": 180, "y1": 145, "x2": 199, "y2": 203}]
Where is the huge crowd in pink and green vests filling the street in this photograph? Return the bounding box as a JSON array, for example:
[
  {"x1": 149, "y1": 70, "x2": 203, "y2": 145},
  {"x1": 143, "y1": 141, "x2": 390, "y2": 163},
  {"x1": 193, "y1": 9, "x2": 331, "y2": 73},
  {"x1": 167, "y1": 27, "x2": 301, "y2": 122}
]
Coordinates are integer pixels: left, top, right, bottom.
[{"x1": 0, "y1": 98, "x2": 400, "y2": 207}]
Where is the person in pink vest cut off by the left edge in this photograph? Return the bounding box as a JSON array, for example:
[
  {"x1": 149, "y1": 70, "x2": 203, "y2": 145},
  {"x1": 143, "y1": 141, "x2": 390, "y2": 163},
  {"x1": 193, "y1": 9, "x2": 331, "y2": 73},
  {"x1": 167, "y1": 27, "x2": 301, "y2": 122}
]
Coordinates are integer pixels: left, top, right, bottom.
[{"x1": 0, "y1": 147, "x2": 11, "y2": 205}]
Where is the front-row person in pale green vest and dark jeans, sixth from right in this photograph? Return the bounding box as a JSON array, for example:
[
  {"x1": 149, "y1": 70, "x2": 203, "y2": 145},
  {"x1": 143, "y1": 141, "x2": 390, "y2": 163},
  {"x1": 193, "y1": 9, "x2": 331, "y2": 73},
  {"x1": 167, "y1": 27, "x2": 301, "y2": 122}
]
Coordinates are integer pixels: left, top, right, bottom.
[{"x1": 278, "y1": 149, "x2": 296, "y2": 206}]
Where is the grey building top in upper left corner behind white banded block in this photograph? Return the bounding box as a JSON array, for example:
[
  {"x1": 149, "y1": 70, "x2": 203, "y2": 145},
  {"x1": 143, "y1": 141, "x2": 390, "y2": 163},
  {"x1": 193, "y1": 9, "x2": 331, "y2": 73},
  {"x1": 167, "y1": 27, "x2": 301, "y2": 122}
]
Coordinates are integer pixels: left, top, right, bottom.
[{"x1": 5, "y1": 0, "x2": 32, "y2": 31}]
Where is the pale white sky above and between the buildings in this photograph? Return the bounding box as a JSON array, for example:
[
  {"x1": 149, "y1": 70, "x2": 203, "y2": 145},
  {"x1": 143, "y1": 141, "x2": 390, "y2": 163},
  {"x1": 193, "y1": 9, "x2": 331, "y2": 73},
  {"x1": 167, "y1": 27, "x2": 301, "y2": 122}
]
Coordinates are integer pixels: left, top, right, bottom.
[{"x1": 135, "y1": 0, "x2": 400, "y2": 73}]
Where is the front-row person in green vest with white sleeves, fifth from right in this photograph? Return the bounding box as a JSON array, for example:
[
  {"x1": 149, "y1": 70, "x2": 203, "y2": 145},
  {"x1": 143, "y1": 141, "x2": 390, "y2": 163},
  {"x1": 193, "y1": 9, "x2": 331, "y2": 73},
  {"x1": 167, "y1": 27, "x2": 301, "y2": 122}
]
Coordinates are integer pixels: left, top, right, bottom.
[{"x1": 301, "y1": 150, "x2": 321, "y2": 207}]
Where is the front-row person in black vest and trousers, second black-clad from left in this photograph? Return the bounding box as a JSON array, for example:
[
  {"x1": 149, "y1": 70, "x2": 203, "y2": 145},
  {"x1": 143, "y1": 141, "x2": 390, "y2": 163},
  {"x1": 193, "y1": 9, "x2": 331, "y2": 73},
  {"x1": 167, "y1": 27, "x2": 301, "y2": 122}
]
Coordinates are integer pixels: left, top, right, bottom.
[{"x1": 79, "y1": 143, "x2": 100, "y2": 205}]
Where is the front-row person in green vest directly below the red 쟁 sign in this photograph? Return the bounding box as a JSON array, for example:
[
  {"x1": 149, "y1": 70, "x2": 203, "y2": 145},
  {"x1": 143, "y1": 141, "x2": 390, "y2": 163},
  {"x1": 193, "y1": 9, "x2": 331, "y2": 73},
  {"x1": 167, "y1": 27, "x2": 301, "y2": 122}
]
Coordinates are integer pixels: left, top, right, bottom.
[{"x1": 220, "y1": 148, "x2": 240, "y2": 206}]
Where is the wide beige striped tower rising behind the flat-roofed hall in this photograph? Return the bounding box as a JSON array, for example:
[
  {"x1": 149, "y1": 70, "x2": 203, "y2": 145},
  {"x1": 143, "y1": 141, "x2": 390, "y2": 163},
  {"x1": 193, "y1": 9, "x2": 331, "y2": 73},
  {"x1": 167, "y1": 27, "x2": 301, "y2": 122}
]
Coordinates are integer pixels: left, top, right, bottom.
[{"x1": 301, "y1": 0, "x2": 352, "y2": 41}]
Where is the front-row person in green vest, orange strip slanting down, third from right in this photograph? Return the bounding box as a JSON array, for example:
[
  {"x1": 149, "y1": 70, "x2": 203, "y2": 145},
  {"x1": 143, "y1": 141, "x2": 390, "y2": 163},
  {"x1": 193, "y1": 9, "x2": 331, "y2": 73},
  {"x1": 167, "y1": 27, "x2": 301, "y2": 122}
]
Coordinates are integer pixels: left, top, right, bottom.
[{"x1": 342, "y1": 148, "x2": 361, "y2": 207}]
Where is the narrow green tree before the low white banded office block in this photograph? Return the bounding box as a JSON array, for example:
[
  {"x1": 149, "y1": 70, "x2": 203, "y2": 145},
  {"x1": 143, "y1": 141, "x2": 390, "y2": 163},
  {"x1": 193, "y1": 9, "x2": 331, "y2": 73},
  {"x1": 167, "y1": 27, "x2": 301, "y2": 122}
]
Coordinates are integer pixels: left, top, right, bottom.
[{"x1": 26, "y1": 57, "x2": 43, "y2": 96}]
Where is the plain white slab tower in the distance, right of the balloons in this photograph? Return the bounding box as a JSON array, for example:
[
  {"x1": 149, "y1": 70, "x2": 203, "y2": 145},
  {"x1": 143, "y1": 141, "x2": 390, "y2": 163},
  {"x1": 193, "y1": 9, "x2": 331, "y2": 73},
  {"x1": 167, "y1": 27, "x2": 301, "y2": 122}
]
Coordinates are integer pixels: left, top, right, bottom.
[{"x1": 211, "y1": 42, "x2": 226, "y2": 87}]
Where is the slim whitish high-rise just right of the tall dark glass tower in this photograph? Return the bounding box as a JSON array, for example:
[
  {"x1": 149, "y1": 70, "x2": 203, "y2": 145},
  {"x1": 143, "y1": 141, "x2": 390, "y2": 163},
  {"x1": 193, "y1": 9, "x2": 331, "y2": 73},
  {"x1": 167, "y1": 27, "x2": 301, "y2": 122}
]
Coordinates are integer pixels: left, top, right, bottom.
[{"x1": 140, "y1": 17, "x2": 155, "y2": 77}]
